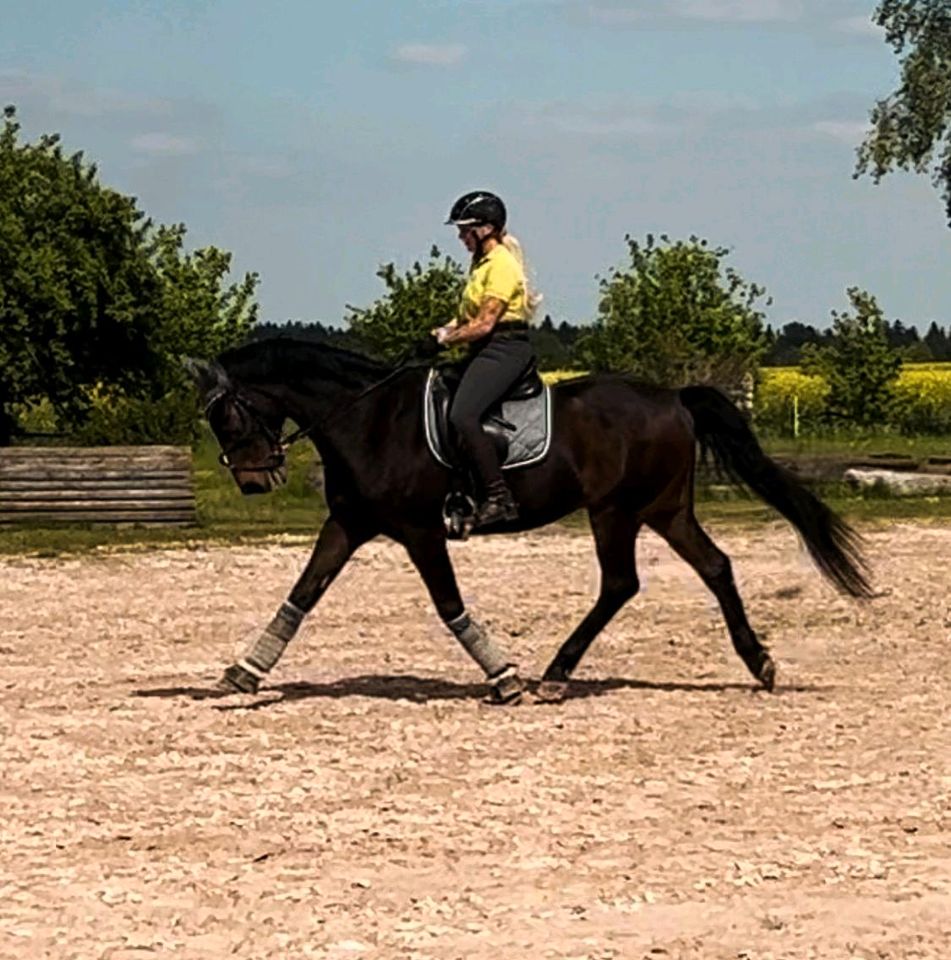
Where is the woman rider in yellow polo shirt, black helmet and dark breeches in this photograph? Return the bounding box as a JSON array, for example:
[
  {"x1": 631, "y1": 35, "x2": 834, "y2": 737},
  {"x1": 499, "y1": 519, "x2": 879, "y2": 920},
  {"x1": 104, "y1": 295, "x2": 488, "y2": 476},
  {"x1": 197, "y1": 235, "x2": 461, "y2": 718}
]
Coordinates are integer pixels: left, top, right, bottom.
[{"x1": 433, "y1": 190, "x2": 538, "y2": 527}]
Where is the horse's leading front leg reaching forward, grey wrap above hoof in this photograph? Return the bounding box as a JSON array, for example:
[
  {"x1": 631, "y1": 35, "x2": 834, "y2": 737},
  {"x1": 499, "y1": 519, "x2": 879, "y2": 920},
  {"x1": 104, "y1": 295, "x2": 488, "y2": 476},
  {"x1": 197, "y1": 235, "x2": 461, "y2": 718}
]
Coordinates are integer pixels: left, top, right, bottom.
[{"x1": 217, "y1": 517, "x2": 373, "y2": 693}]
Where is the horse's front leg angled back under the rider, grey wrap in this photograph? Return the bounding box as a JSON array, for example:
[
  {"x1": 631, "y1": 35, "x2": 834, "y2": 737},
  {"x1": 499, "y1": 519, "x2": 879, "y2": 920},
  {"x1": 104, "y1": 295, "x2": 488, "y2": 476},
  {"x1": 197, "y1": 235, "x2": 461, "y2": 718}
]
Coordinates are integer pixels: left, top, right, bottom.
[{"x1": 405, "y1": 531, "x2": 524, "y2": 704}]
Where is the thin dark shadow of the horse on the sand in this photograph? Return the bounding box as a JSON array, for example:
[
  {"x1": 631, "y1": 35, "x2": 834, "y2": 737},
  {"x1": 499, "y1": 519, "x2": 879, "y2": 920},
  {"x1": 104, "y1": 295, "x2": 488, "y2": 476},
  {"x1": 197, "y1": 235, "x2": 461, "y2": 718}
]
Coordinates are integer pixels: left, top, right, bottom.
[{"x1": 132, "y1": 674, "x2": 827, "y2": 710}]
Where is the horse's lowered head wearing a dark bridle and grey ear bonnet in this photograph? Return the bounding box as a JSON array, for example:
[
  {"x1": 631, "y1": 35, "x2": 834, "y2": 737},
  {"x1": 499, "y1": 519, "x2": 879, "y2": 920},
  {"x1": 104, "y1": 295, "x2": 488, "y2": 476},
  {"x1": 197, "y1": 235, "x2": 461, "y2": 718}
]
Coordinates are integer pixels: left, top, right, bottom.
[{"x1": 184, "y1": 358, "x2": 287, "y2": 494}]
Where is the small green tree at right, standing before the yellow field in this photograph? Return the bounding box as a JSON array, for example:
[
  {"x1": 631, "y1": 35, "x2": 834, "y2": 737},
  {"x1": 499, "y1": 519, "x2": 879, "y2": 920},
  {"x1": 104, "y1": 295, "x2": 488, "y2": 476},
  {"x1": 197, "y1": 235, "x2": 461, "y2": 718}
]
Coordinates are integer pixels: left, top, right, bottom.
[{"x1": 802, "y1": 287, "x2": 901, "y2": 427}]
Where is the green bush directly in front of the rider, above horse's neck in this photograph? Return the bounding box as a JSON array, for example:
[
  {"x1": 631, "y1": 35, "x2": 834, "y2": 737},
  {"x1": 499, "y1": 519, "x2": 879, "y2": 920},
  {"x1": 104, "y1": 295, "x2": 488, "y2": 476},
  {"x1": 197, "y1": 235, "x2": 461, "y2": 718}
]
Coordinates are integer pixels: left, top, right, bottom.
[{"x1": 346, "y1": 247, "x2": 466, "y2": 360}]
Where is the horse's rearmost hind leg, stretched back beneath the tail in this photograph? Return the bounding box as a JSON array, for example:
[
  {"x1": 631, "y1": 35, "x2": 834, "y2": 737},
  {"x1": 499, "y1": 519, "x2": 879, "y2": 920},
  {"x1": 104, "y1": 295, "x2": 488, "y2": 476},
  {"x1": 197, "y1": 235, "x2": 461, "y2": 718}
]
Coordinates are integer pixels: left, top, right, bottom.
[{"x1": 647, "y1": 507, "x2": 776, "y2": 690}]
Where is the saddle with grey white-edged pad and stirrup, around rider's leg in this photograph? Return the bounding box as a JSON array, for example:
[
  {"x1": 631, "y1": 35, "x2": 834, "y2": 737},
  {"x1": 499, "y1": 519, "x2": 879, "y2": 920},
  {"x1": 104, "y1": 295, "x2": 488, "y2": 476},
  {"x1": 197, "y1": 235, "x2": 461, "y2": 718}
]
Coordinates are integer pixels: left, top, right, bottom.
[{"x1": 423, "y1": 363, "x2": 551, "y2": 539}]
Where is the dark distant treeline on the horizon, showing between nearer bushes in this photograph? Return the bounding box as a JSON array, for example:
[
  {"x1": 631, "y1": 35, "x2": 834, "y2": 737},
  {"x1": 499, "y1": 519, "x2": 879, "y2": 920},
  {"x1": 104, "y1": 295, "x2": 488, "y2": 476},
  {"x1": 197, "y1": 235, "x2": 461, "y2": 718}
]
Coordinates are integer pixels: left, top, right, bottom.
[{"x1": 250, "y1": 316, "x2": 951, "y2": 370}]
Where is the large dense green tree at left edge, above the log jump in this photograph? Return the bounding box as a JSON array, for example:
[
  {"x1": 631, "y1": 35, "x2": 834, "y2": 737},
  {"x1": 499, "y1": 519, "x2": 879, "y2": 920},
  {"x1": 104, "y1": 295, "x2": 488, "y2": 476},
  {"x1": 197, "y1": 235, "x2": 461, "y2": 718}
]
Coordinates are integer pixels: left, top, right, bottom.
[{"x1": 0, "y1": 107, "x2": 256, "y2": 445}]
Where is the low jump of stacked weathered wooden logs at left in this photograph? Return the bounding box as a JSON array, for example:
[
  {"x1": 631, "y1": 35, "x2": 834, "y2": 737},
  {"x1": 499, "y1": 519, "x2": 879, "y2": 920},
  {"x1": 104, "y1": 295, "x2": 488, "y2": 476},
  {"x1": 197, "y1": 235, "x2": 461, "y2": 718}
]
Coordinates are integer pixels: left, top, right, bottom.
[{"x1": 0, "y1": 446, "x2": 197, "y2": 526}]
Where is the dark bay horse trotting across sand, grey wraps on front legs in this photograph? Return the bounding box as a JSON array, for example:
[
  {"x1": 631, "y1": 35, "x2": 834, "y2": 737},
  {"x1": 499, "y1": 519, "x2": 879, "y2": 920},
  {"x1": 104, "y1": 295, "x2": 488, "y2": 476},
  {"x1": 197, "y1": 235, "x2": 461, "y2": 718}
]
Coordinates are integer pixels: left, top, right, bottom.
[{"x1": 182, "y1": 339, "x2": 871, "y2": 703}]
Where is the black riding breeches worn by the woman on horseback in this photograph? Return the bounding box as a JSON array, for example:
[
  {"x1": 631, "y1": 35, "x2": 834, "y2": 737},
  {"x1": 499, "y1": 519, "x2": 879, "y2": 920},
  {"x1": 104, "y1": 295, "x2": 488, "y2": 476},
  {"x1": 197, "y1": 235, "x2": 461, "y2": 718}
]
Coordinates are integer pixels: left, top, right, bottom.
[{"x1": 449, "y1": 331, "x2": 534, "y2": 491}]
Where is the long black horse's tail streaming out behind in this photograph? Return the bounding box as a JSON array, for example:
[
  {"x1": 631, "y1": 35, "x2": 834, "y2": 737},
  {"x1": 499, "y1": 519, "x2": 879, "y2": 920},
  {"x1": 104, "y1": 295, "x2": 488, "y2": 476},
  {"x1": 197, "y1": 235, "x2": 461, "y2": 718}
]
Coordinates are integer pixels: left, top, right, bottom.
[{"x1": 680, "y1": 386, "x2": 873, "y2": 598}]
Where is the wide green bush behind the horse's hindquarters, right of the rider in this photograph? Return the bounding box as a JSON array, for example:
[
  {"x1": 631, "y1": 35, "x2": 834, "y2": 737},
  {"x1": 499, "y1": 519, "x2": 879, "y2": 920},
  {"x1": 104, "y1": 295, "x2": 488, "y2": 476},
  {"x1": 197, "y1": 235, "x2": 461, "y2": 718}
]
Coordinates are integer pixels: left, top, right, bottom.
[{"x1": 575, "y1": 235, "x2": 768, "y2": 390}]
